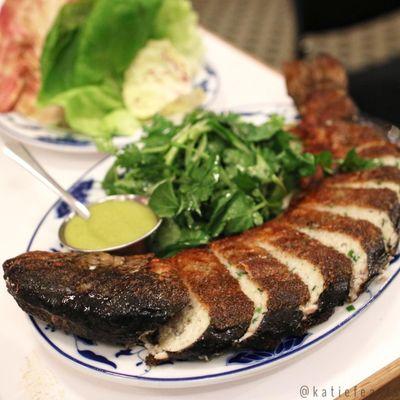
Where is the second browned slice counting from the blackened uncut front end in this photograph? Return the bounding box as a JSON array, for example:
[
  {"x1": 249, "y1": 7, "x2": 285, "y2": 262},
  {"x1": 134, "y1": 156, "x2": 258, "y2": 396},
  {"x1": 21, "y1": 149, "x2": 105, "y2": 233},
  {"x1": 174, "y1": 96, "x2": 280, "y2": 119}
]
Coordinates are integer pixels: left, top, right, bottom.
[{"x1": 211, "y1": 235, "x2": 310, "y2": 349}]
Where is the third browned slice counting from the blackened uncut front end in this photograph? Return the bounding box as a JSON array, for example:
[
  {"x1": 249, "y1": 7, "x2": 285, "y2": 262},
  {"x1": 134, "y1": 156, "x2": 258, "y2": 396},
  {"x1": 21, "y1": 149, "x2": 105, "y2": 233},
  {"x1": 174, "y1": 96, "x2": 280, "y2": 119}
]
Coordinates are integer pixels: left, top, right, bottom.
[{"x1": 244, "y1": 223, "x2": 352, "y2": 326}]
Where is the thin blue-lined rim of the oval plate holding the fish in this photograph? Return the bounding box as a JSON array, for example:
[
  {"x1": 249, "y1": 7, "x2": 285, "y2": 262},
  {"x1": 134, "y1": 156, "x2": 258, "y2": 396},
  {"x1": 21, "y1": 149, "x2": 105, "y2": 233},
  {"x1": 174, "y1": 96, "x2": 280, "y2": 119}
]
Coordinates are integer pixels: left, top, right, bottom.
[{"x1": 27, "y1": 111, "x2": 400, "y2": 386}]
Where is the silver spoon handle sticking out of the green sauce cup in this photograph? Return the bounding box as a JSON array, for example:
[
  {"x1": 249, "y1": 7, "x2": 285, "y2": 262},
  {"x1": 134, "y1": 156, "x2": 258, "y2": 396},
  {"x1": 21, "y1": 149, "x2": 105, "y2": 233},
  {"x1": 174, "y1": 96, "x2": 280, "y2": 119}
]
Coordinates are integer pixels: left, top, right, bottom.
[{"x1": 3, "y1": 140, "x2": 90, "y2": 219}]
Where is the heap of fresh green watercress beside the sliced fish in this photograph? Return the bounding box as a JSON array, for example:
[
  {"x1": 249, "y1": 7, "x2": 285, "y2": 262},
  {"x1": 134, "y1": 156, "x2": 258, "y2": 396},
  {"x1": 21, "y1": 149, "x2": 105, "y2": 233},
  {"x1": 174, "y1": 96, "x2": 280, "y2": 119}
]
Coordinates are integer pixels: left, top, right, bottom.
[{"x1": 103, "y1": 110, "x2": 372, "y2": 256}]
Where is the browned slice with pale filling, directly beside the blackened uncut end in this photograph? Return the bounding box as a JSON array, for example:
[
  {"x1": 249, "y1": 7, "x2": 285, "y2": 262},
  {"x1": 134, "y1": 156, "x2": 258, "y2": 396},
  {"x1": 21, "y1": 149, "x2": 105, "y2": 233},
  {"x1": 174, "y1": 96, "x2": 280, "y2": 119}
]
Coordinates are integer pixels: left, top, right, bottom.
[{"x1": 146, "y1": 248, "x2": 254, "y2": 364}]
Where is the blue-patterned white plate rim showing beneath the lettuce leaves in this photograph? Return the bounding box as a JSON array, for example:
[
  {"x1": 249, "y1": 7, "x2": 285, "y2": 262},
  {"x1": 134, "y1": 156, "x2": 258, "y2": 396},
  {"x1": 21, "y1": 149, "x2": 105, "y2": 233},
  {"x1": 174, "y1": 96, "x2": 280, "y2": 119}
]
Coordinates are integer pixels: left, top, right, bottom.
[{"x1": 0, "y1": 62, "x2": 220, "y2": 153}]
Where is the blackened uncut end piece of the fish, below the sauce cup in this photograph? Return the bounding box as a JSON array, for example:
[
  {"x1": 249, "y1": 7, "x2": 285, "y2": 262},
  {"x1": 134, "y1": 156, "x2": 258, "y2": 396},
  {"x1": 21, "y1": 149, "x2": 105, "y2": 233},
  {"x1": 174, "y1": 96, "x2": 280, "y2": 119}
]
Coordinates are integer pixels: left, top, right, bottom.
[{"x1": 4, "y1": 251, "x2": 189, "y2": 345}]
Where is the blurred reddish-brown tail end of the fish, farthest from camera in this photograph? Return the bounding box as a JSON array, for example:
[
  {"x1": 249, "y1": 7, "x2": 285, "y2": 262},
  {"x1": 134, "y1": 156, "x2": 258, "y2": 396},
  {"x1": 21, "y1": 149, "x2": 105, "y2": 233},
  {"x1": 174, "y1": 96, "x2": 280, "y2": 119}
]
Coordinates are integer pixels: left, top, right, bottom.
[{"x1": 284, "y1": 55, "x2": 400, "y2": 167}]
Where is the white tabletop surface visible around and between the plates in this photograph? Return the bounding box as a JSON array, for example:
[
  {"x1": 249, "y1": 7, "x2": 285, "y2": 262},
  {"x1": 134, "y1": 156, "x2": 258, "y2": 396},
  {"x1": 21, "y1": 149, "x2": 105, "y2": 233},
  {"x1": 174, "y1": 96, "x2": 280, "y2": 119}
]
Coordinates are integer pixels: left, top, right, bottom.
[{"x1": 0, "y1": 29, "x2": 400, "y2": 400}]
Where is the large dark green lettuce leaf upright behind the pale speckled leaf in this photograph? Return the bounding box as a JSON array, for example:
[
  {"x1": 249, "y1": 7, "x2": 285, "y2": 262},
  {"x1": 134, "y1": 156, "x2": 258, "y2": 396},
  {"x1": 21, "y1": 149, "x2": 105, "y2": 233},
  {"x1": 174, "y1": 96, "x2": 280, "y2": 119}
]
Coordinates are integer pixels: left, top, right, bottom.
[{"x1": 39, "y1": 0, "x2": 161, "y2": 104}]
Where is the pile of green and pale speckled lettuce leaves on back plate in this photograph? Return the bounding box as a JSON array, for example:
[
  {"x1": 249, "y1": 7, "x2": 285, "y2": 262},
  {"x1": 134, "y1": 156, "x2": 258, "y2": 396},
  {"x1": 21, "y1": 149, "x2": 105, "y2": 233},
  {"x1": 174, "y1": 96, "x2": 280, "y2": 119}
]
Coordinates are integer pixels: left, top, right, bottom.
[{"x1": 38, "y1": 0, "x2": 202, "y2": 143}]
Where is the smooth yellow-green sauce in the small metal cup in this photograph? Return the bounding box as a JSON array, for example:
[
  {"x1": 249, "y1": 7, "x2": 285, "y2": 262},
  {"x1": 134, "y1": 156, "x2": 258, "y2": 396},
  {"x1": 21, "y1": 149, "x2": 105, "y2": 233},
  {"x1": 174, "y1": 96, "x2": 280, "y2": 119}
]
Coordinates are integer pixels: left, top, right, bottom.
[{"x1": 64, "y1": 200, "x2": 157, "y2": 250}]
